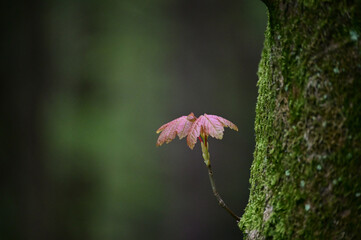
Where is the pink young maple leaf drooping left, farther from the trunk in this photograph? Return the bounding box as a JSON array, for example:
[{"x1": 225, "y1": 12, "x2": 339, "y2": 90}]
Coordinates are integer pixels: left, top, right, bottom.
[{"x1": 156, "y1": 113, "x2": 197, "y2": 146}]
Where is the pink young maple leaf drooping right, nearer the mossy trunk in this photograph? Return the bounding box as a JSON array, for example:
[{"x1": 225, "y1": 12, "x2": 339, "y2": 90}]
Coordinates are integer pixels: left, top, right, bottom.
[{"x1": 187, "y1": 114, "x2": 238, "y2": 149}]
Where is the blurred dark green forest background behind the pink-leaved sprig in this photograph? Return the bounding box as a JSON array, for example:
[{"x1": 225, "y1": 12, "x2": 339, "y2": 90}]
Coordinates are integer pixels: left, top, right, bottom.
[{"x1": 0, "y1": 0, "x2": 267, "y2": 240}]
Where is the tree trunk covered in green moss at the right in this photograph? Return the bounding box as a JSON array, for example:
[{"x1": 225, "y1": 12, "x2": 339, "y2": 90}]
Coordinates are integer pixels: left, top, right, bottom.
[{"x1": 239, "y1": 0, "x2": 361, "y2": 239}]
